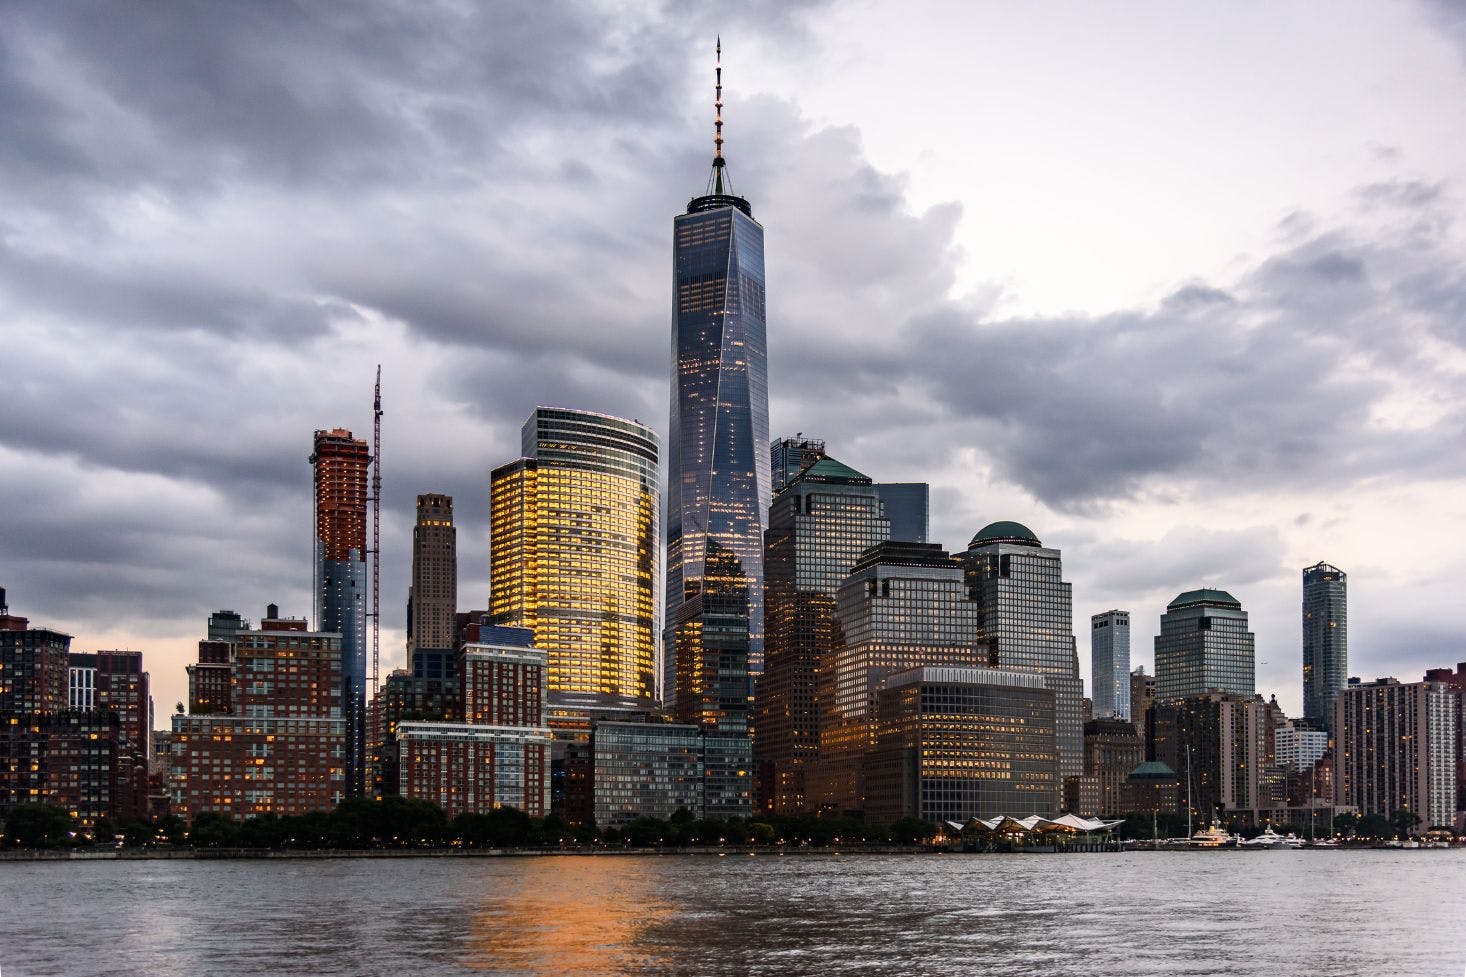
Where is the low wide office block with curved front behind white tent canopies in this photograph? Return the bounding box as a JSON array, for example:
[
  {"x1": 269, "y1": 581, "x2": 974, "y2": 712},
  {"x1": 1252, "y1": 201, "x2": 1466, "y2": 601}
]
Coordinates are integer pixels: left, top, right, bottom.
[{"x1": 865, "y1": 666, "x2": 1058, "y2": 823}]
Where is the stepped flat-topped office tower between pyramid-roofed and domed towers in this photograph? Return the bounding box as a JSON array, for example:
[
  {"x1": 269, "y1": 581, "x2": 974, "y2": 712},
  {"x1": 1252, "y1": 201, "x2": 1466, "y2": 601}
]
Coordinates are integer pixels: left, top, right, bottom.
[{"x1": 805, "y1": 541, "x2": 985, "y2": 811}]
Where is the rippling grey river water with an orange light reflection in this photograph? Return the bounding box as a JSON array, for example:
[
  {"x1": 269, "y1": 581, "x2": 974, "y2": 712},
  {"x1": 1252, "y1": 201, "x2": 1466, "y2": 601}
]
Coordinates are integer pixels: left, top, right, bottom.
[{"x1": 0, "y1": 851, "x2": 1466, "y2": 977}]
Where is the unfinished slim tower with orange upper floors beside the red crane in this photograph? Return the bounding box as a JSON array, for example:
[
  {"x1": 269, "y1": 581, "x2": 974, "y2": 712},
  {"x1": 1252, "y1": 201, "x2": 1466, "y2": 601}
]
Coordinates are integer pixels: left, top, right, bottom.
[{"x1": 311, "y1": 428, "x2": 371, "y2": 797}]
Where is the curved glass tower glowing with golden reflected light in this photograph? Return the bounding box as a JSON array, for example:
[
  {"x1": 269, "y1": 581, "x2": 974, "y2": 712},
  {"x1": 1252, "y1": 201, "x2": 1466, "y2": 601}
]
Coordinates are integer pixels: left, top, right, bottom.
[{"x1": 488, "y1": 408, "x2": 660, "y2": 726}]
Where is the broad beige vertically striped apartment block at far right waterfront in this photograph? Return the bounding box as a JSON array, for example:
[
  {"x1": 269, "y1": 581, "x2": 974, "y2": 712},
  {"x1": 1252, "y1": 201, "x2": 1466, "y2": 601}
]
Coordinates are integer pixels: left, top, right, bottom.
[{"x1": 1334, "y1": 678, "x2": 1457, "y2": 832}]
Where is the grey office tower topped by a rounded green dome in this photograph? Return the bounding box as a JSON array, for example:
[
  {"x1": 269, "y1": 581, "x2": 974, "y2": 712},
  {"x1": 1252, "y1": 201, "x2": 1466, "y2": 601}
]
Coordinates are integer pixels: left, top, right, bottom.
[{"x1": 957, "y1": 521, "x2": 1085, "y2": 779}]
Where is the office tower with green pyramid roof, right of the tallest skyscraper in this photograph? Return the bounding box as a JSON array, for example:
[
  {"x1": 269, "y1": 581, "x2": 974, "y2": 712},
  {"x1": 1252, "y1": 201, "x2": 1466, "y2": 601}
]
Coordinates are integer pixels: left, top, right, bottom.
[{"x1": 755, "y1": 451, "x2": 890, "y2": 814}]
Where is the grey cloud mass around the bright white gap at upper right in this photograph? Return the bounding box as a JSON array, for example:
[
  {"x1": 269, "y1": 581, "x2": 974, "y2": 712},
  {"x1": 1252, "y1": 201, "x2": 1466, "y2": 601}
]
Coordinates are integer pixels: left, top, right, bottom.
[{"x1": 0, "y1": 3, "x2": 1466, "y2": 718}]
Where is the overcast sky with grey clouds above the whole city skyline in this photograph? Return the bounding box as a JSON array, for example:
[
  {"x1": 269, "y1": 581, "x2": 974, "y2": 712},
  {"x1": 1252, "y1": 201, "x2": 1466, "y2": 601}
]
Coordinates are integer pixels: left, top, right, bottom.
[{"x1": 0, "y1": 0, "x2": 1466, "y2": 715}]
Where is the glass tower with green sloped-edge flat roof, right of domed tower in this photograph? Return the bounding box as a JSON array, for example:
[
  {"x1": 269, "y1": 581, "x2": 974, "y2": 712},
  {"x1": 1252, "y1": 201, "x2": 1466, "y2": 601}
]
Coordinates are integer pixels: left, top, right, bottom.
[{"x1": 1155, "y1": 588, "x2": 1256, "y2": 701}]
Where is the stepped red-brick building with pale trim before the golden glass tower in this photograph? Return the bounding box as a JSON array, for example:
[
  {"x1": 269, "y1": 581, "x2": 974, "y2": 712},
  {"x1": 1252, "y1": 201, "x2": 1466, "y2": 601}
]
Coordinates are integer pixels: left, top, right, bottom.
[{"x1": 396, "y1": 626, "x2": 550, "y2": 817}]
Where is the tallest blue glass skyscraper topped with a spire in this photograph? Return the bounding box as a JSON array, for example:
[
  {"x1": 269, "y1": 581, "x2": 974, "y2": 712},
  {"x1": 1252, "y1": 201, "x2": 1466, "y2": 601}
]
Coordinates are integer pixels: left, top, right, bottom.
[{"x1": 664, "y1": 41, "x2": 771, "y2": 714}]
